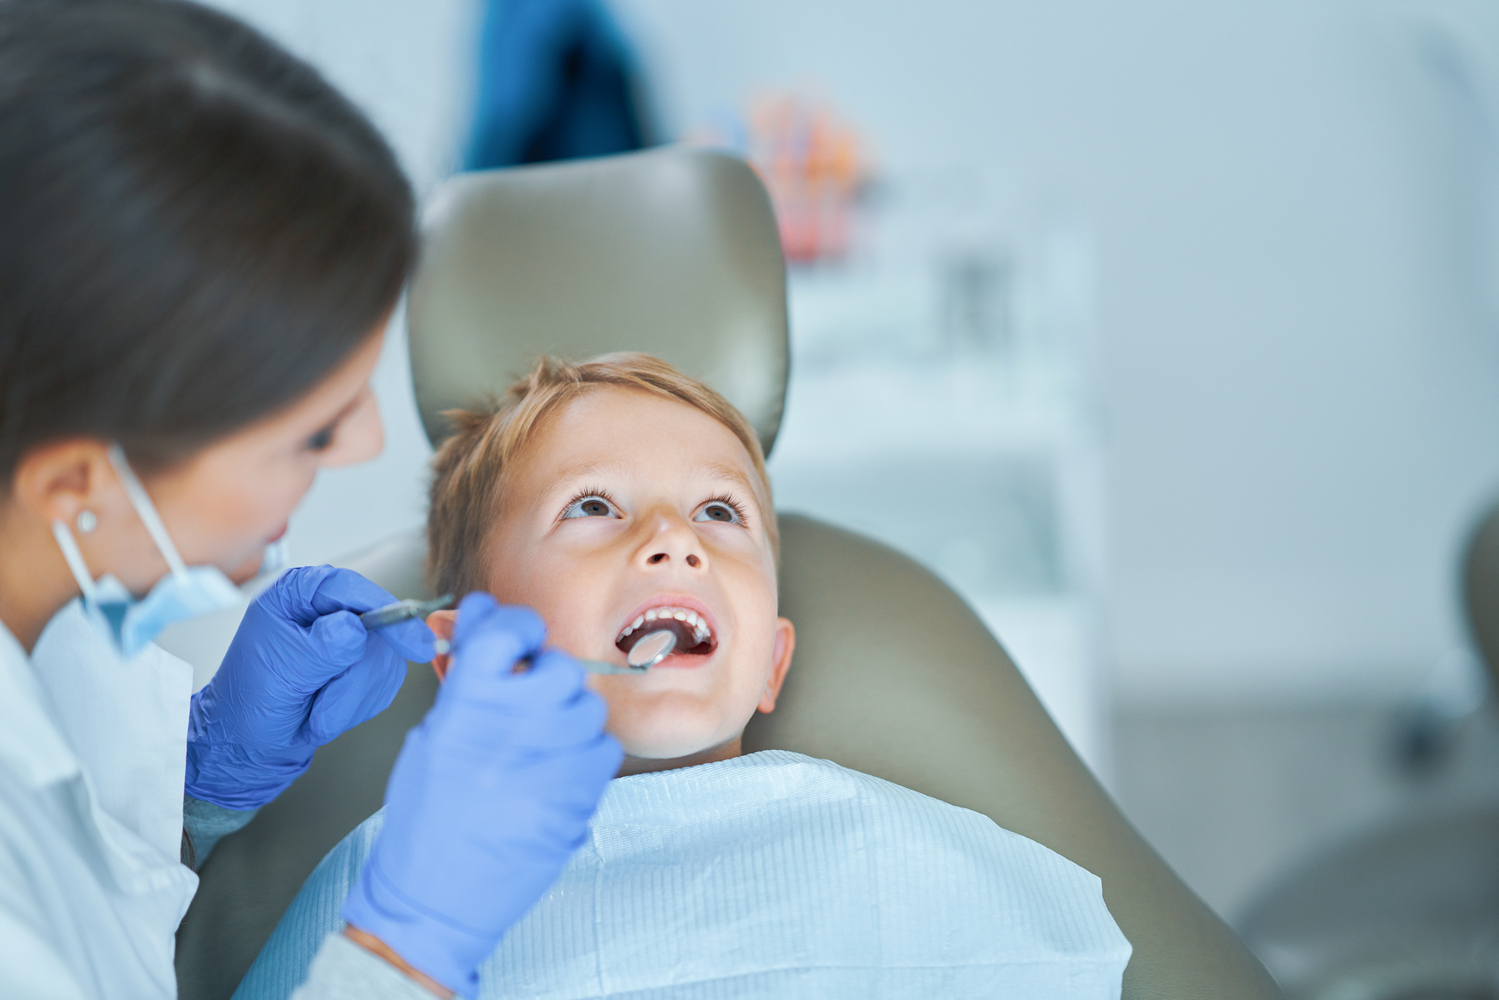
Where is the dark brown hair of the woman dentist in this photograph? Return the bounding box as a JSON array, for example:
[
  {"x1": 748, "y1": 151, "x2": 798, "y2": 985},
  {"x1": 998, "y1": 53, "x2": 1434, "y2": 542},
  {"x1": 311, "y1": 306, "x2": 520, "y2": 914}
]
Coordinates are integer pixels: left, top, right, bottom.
[{"x1": 0, "y1": 0, "x2": 417, "y2": 483}]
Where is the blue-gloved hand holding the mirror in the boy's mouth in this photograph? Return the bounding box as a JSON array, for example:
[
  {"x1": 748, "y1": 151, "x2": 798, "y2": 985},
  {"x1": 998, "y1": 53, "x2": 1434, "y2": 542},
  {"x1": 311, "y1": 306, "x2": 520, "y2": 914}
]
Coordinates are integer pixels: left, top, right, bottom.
[{"x1": 343, "y1": 594, "x2": 624, "y2": 996}]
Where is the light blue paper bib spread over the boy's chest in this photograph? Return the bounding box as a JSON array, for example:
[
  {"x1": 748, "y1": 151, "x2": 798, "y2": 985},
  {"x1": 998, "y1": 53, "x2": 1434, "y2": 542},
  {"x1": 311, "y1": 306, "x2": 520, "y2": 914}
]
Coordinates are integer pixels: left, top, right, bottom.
[{"x1": 521, "y1": 751, "x2": 1129, "y2": 997}]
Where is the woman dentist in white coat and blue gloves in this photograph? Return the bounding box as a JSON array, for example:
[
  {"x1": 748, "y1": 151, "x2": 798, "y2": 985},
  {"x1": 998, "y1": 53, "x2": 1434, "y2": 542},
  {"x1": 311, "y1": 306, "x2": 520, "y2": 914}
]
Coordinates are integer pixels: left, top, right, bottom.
[{"x1": 0, "y1": 0, "x2": 621, "y2": 1000}]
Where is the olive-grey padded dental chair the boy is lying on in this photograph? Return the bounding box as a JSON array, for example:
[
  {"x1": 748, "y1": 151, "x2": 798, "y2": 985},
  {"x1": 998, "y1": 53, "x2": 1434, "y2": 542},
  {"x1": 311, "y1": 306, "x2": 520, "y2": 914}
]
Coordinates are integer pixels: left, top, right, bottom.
[{"x1": 177, "y1": 148, "x2": 1280, "y2": 1000}]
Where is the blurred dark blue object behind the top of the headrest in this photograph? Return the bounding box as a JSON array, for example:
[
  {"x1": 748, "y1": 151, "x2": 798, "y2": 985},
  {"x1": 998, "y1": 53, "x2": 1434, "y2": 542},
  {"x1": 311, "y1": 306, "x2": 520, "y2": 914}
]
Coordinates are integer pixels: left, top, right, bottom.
[{"x1": 465, "y1": 0, "x2": 646, "y2": 169}]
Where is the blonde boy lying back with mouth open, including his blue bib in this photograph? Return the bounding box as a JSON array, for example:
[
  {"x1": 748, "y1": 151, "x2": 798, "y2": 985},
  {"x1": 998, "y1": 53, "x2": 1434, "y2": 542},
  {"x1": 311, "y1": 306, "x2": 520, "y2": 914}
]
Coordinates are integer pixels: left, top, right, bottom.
[{"x1": 235, "y1": 354, "x2": 1130, "y2": 1000}]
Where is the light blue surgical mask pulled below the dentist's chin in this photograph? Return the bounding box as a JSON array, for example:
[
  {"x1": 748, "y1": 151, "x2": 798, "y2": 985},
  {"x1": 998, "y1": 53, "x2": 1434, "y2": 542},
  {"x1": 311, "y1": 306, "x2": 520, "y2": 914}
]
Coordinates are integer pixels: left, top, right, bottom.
[{"x1": 52, "y1": 444, "x2": 240, "y2": 657}]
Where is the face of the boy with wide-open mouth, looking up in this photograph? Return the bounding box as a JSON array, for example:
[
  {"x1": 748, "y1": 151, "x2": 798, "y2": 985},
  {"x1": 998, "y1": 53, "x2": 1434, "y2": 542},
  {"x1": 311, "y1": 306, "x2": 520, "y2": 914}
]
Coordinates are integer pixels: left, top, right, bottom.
[{"x1": 487, "y1": 387, "x2": 794, "y2": 772}]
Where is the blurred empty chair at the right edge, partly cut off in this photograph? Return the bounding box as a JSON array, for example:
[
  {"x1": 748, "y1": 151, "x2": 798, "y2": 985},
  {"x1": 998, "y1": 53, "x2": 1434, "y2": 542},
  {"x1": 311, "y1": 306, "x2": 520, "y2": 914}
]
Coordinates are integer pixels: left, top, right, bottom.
[{"x1": 1240, "y1": 505, "x2": 1499, "y2": 1000}]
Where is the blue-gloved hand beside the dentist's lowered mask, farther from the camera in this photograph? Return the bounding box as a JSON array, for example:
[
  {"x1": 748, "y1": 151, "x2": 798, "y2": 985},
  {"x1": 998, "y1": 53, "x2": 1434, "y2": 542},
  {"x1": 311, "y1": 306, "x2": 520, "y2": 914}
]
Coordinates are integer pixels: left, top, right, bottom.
[{"x1": 186, "y1": 565, "x2": 435, "y2": 810}]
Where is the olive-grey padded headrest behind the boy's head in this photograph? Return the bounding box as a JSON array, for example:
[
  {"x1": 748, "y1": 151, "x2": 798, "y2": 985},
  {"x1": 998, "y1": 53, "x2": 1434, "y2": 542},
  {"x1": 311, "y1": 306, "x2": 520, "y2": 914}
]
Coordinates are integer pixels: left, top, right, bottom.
[{"x1": 406, "y1": 147, "x2": 788, "y2": 453}]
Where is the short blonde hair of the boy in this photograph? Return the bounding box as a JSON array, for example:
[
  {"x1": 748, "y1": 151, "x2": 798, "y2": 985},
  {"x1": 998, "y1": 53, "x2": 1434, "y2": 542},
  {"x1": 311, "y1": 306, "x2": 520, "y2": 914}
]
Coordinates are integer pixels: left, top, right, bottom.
[{"x1": 427, "y1": 351, "x2": 781, "y2": 594}]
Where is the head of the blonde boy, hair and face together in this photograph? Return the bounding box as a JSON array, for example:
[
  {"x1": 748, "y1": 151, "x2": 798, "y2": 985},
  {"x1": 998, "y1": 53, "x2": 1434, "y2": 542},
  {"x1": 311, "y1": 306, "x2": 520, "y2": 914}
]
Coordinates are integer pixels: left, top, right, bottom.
[{"x1": 427, "y1": 355, "x2": 794, "y2": 774}]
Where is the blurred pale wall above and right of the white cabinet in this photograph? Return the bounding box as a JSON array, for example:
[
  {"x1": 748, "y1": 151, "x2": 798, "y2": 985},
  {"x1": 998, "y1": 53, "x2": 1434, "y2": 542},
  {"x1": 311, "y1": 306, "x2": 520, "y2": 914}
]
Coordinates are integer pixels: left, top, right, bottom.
[{"x1": 625, "y1": 0, "x2": 1499, "y2": 699}]
